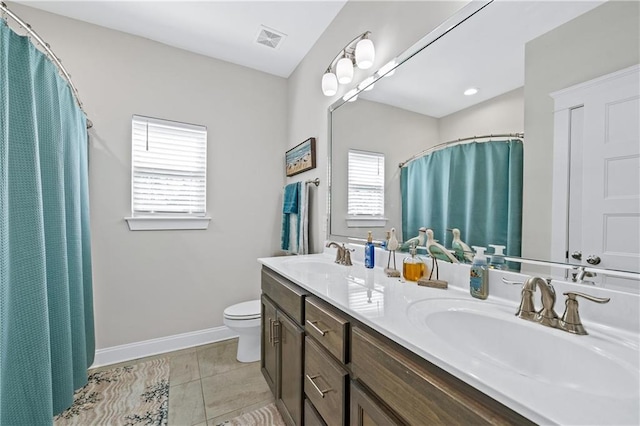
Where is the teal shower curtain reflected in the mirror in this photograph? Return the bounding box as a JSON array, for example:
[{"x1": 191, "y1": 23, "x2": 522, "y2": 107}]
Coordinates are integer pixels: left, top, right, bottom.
[{"x1": 400, "y1": 139, "x2": 523, "y2": 256}]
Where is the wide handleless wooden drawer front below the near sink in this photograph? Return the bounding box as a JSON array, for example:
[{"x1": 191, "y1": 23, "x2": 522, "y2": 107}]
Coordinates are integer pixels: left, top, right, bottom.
[{"x1": 351, "y1": 327, "x2": 532, "y2": 425}]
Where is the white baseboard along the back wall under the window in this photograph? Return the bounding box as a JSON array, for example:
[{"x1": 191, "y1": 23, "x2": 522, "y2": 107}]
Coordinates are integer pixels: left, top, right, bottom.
[{"x1": 91, "y1": 325, "x2": 238, "y2": 368}]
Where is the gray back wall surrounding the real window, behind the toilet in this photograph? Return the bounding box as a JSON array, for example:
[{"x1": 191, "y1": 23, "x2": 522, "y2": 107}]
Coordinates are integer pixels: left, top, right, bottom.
[{"x1": 10, "y1": 3, "x2": 287, "y2": 349}]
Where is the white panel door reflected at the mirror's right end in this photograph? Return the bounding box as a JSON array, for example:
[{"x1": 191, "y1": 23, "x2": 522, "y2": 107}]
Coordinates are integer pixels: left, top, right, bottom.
[{"x1": 570, "y1": 68, "x2": 640, "y2": 283}]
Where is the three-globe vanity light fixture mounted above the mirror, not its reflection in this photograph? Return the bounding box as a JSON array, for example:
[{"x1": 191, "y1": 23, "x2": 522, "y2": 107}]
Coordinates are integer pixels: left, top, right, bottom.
[{"x1": 322, "y1": 31, "x2": 375, "y2": 96}]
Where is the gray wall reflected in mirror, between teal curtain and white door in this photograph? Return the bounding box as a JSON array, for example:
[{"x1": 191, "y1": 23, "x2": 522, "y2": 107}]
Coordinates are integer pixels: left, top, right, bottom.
[{"x1": 522, "y1": 1, "x2": 640, "y2": 259}]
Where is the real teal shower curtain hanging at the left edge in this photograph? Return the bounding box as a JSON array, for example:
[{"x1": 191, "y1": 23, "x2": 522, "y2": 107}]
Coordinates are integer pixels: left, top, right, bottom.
[{"x1": 0, "y1": 21, "x2": 95, "y2": 425}]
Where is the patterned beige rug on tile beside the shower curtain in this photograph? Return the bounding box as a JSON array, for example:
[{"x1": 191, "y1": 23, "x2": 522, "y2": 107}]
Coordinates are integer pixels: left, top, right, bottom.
[{"x1": 54, "y1": 358, "x2": 169, "y2": 426}]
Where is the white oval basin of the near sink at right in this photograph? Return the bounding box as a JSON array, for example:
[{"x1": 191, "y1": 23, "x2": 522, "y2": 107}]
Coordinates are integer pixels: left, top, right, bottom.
[{"x1": 407, "y1": 299, "x2": 640, "y2": 398}]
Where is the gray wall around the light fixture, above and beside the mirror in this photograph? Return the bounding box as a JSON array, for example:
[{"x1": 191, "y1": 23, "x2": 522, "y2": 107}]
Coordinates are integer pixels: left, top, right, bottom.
[{"x1": 287, "y1": 1, "x2": 467, "y2": 252}]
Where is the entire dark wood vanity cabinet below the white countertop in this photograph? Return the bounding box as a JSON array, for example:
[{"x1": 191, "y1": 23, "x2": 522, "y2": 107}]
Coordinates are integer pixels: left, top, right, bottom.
[{"x1": 261, "y1": 268, "x2": 533, "y2": 426}]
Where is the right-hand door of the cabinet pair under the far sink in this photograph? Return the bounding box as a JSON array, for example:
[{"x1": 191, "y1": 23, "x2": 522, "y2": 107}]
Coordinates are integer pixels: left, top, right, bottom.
[{"x1": 276, "y1": 312, "x2": 304, "y2": 425}]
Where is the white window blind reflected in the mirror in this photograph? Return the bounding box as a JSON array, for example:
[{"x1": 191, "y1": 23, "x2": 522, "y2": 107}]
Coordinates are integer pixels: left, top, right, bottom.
[{"x1": 348, "y1": 150, "x2": 384, "y2": 217}]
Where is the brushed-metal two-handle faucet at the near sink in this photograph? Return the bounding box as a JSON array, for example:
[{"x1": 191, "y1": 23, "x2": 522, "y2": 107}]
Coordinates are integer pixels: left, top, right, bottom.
[{"x1": 502, "y1": 277, "x2": 610, "y2": 335}]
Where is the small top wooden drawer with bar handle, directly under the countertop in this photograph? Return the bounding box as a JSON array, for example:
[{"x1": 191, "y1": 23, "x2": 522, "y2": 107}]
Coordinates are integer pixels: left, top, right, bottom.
[{"x1": 304, "y1": 297, "x2": 349, "y2": 364}]
